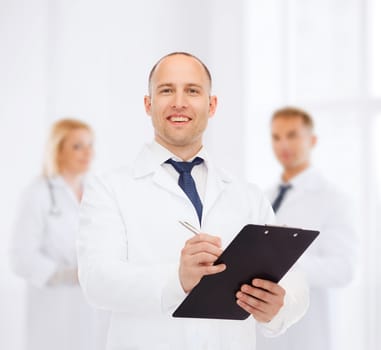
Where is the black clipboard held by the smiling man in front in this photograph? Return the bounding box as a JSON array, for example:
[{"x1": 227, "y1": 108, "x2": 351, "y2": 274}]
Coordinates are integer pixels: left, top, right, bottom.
[{"x1": 172, "y1": 225, "x2": 319, "y2": 320}]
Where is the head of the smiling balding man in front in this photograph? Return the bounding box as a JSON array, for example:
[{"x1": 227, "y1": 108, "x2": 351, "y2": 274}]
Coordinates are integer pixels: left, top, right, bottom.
[{"x1": 144, "y1": 54, "x2": 217, "y2": 159}]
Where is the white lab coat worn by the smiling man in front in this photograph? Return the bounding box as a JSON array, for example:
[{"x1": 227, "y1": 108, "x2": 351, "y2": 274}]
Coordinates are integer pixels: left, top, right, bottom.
[{"x1": 78, "y1": 146, "x2": 308, "y2": 350}]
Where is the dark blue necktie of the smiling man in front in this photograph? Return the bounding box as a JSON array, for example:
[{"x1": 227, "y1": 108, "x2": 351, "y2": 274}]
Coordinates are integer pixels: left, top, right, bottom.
[{"x1": 166, "y1": 157, "x2": 204, "y2": 224}]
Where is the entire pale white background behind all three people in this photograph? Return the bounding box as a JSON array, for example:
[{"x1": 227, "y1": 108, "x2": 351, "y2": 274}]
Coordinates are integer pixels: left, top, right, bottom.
[{"x1": 0, "y1": 0, "x2": 381, "y2": 350}]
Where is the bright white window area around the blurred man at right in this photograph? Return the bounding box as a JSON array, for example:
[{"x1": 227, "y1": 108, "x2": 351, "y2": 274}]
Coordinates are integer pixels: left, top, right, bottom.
[{"x1": 245, "y1": 0, "x2": 381, "y2": 350}]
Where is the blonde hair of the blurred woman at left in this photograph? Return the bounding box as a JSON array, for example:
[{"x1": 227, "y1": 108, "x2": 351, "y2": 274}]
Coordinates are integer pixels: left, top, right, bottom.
[{"x1": 43, "y1": 118, "x2": 93, "y2": 177}]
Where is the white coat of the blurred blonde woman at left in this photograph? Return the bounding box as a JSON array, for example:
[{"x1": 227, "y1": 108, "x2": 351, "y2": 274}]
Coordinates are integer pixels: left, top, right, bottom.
[{"x1": 10, "y1": 177, "x2": 107, "y2": 350}]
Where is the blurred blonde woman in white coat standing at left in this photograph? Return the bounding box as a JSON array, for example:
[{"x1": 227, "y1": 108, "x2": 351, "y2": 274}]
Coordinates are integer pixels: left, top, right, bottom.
[{"x1": 11, "y1": 119, "x2": 105, "y2": 350}]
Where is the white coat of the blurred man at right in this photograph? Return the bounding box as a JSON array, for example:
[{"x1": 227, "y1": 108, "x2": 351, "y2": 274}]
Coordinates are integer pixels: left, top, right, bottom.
[{"x1": 258, "y1": 168, "x2": 356, "y2": 350}]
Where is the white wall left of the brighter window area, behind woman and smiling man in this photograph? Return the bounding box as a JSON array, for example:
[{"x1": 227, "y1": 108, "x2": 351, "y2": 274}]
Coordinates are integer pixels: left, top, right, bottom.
[{"x1": 0, "y1": 0, "x2": 244, "y2": 350}]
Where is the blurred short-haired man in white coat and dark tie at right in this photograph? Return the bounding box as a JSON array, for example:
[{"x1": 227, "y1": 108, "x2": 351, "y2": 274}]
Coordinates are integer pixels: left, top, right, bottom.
[{"x1": 258, "y1": 107, "x2": 355, "y2": 350}]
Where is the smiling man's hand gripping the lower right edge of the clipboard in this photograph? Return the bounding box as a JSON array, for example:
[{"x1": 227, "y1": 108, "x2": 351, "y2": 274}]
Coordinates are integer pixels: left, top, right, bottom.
[{"x1": 236, "y1": 278, "x2": 286, "y2": 323}]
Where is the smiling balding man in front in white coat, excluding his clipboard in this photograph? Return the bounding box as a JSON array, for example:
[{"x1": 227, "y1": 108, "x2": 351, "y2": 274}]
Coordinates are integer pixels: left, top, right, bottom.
[{"x1": 77, "y1": 53, "x2": 308, "y2": 350}]
